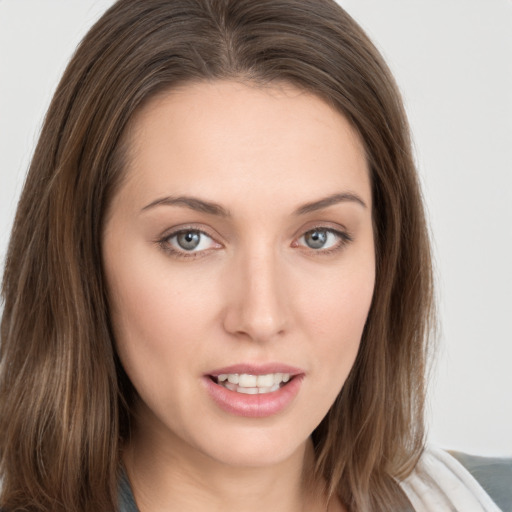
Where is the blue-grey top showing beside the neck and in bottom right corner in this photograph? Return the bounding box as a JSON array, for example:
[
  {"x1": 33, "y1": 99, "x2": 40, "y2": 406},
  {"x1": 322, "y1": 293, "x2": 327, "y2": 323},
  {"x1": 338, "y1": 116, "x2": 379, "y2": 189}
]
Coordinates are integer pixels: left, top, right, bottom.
[{"x1": 119, "y1": 452, "x2": 512, "y2": 512}]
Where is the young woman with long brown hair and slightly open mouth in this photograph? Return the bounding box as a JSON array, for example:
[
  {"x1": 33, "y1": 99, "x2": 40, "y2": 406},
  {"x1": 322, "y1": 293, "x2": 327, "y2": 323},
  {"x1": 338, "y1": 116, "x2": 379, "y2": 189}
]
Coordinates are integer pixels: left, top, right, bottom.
[{"x1": 0, "y1": 0, "x2": 508, "y2": 512}]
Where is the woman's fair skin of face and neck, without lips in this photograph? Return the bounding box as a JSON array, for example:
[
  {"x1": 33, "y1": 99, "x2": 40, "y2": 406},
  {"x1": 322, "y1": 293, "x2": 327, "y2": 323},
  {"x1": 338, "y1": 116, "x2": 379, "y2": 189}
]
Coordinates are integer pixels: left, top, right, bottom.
[{"x1": 103, "y1": 81, "x2": 375, "y2": 512}]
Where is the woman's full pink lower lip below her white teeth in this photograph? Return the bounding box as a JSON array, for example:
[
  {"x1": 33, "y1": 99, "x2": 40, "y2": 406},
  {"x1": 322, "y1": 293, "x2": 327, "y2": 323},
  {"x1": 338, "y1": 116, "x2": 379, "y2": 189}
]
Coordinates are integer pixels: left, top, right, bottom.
[{"x1": 204, "y1": 375, "x2": 304, "y2": 418}]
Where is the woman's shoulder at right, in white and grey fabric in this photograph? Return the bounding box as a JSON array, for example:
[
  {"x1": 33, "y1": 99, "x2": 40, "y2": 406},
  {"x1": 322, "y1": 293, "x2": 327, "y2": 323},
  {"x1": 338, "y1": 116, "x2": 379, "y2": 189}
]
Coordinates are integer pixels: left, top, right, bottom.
[{"x1": 401, "y1": 447, "x2": 512, "y2": 512}]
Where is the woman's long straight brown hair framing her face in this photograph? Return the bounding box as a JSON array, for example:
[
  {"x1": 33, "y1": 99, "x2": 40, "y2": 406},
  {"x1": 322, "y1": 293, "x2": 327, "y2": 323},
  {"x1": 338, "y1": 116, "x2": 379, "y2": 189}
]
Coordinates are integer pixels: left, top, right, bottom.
[{"x1": 0, "y1": 0, "x2": 432, "y2": 512}]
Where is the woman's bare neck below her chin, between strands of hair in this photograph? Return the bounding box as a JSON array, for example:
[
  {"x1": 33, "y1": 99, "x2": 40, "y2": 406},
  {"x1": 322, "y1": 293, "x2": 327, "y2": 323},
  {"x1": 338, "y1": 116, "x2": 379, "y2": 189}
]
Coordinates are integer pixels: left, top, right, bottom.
[{"x1": 124, "y1": 414, "x2": 327, "y2": 512}]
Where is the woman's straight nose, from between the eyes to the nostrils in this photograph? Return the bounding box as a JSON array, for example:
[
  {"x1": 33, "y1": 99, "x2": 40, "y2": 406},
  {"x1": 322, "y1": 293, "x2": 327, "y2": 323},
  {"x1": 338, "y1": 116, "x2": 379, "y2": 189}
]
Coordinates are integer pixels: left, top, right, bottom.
[{"x1": 224, "y1": 246, "x2": 289, "y2": 342}]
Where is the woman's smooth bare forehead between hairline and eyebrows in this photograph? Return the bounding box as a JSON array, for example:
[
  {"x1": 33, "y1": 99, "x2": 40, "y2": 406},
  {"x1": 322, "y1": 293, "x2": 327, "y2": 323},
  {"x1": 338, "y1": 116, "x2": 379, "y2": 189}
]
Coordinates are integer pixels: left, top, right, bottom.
[{"x1": 118, "y1": 81, "x2": 371, "y2": 210}]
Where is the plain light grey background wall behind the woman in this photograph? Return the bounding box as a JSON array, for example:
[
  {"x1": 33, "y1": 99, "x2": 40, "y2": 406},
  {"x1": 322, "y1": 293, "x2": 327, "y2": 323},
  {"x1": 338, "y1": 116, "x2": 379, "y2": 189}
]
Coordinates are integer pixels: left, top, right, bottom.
[{"x1": 0, "y1": 0, "x2": 512, "y2": 456}]
